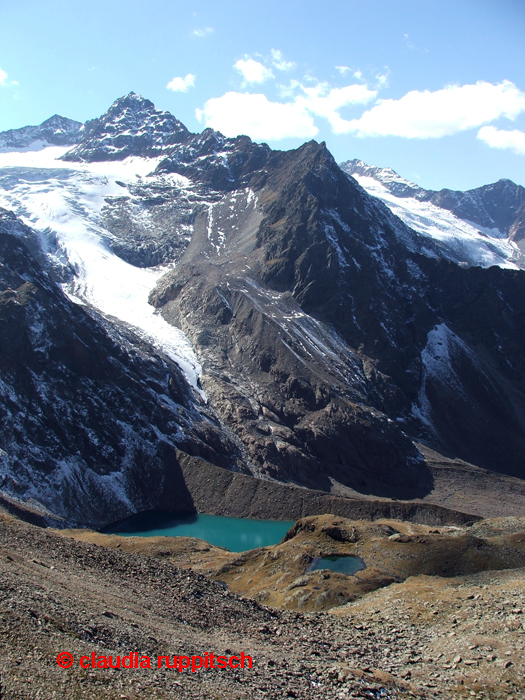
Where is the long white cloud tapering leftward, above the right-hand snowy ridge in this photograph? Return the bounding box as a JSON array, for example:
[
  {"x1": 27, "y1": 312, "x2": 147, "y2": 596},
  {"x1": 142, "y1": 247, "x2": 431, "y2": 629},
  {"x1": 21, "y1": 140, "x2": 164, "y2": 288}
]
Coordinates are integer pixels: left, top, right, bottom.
[{"x1": 338, "y1": 80, "x2": 525, "y2": 139}]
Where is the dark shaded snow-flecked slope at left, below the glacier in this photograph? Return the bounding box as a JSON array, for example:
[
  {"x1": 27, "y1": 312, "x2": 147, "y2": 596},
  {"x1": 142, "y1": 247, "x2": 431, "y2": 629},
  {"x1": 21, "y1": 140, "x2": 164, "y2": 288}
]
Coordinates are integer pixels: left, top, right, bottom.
[{"x1": 0, "y1": 210, "x2": 246, "y2": 526}]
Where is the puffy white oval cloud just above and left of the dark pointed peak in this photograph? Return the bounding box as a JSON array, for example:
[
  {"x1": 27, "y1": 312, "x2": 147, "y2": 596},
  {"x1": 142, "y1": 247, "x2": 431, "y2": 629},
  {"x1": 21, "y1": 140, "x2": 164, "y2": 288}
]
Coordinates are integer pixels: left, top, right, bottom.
[{"x1": 196, "y1": 92, "x2": 319, "y2": 141}]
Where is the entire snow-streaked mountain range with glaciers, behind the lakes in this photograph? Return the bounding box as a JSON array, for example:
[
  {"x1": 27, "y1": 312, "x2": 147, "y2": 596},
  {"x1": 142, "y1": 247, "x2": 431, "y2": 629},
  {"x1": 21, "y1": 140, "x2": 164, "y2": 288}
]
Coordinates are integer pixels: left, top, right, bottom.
[{"x1": 0, "y1": 93, "x2": 525, "y2": 526}]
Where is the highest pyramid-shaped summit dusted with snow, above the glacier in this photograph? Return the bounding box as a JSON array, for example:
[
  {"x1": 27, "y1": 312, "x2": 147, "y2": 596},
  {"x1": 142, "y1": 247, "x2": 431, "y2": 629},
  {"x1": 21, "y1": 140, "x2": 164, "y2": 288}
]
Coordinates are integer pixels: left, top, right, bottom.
[{"x1": 63, "y1": 92, "x2": 190, "y2": 162}]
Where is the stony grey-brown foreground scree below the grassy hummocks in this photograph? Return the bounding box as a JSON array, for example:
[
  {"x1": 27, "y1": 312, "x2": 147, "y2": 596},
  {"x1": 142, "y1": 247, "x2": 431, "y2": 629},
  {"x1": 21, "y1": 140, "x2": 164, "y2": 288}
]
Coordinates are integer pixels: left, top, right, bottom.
[{"x1": 4, "y1": 514, "x2": 525, "y2": 700}]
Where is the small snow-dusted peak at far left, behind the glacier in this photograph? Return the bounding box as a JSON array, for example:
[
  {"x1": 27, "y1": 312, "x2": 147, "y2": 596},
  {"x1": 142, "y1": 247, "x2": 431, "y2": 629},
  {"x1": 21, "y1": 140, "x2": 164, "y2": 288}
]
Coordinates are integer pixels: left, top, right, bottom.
[{"x1": 0, "y1": 114, "x2": 82, "y2": 151}]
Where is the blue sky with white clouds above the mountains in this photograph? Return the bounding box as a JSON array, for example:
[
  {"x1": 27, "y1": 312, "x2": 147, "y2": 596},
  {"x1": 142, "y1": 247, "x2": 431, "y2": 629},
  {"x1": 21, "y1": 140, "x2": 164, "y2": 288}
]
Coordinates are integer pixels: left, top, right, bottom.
[{"x1": 0, "y1": 0, "x2": 525, "y2": 189}]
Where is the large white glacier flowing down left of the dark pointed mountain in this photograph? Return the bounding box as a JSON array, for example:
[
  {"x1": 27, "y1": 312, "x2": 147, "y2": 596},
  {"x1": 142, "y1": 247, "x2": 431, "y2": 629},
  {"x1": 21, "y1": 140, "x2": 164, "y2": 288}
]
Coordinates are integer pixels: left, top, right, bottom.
[{"x1": 0, "y1": 143, "x2": 206, "y2": 400}]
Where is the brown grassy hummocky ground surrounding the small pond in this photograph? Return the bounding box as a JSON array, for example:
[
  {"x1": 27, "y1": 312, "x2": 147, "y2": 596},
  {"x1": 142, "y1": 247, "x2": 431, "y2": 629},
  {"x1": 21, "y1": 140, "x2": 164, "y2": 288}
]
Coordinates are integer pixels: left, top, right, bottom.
[{"x1": 62, "y1": 515, "x2": 525, "y2": 611}]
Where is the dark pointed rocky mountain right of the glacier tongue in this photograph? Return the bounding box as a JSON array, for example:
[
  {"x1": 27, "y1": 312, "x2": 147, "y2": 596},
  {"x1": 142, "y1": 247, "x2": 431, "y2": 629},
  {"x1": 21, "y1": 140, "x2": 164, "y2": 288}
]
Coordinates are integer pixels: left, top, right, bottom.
[{"x1": 145, "y1": 130, "x2": 525, "y2": 497}]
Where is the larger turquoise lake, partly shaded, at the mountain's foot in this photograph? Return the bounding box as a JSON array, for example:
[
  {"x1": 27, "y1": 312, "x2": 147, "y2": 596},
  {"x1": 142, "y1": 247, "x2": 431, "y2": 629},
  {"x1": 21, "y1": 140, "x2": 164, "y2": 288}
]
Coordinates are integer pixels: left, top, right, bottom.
[{"x1": 103, "y1": 513, "x2": 295, "y2": 552}]
